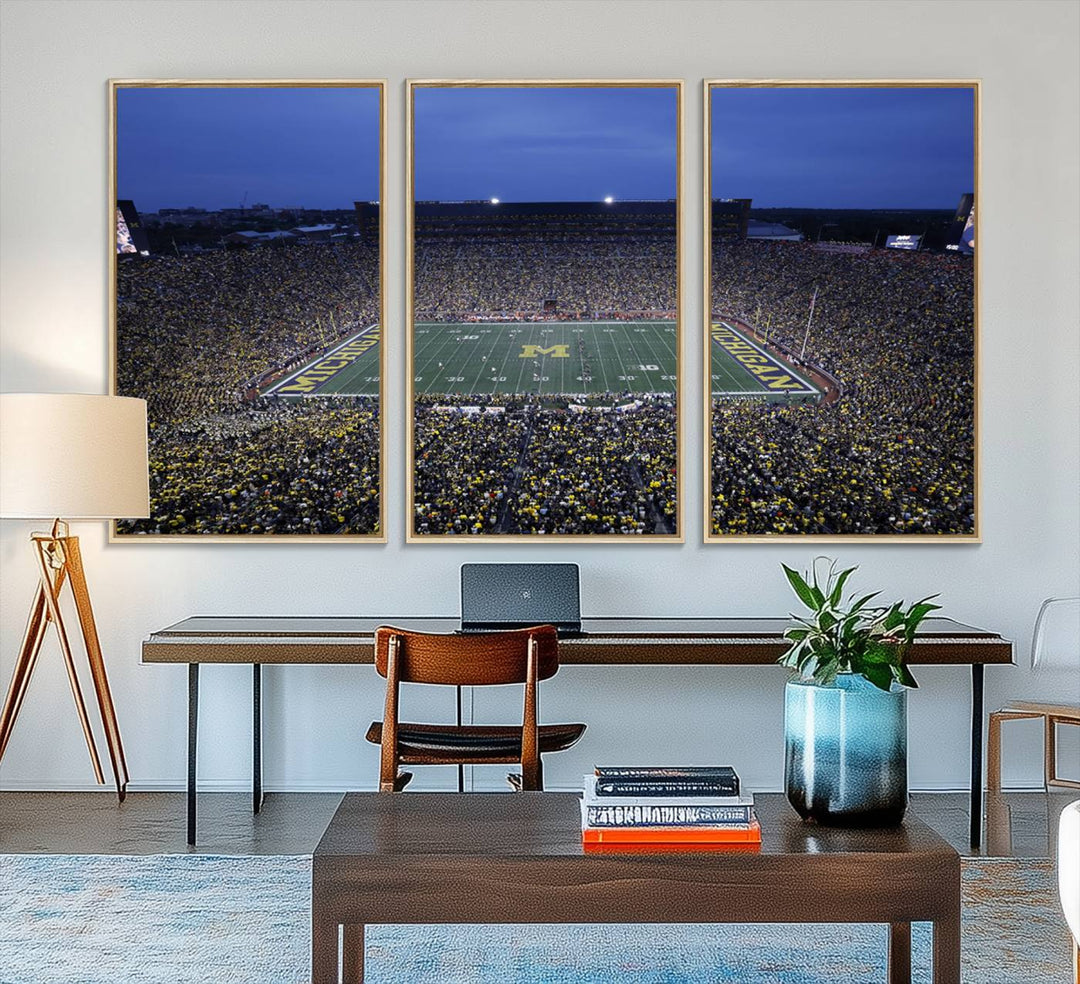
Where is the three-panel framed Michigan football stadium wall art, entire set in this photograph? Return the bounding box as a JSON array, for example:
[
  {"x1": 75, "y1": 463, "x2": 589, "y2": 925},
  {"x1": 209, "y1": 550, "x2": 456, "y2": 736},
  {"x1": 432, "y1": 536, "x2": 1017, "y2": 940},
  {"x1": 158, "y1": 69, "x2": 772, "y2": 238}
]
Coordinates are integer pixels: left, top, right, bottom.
[{"x1": 109, "y1": 80, "x2": 978, "y2": 542}]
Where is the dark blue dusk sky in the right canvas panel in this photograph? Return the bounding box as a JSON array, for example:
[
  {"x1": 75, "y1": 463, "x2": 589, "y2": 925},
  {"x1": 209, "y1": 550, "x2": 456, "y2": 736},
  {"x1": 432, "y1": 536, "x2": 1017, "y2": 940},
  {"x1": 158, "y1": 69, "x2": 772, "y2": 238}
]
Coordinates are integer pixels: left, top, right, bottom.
[{"x1": 712, "y1": 86, "x2": 975, "y2": 208}]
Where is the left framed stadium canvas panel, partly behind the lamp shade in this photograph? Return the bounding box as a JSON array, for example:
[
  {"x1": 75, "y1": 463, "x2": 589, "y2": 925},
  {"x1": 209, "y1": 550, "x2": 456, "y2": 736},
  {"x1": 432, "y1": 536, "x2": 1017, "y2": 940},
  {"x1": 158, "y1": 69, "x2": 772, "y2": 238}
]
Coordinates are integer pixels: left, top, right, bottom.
[{"x1": 109, "y1": 81, "x2": 386, "y2": 542}]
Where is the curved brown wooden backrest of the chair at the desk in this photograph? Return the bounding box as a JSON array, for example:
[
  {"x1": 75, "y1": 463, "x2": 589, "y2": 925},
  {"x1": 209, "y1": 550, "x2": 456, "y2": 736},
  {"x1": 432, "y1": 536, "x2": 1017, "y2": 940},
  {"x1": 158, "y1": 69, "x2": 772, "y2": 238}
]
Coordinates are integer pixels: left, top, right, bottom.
[{"x1": 375, "y1": 625, "x2": 558, "y2": 687}]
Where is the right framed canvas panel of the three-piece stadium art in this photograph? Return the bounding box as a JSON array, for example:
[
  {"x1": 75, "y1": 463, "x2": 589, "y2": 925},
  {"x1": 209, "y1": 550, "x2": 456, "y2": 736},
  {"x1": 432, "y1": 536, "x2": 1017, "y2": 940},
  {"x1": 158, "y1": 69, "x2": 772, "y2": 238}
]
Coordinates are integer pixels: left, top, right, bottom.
[{"x1": 704, "y1": 81, "x2": 978, "y2": 542}]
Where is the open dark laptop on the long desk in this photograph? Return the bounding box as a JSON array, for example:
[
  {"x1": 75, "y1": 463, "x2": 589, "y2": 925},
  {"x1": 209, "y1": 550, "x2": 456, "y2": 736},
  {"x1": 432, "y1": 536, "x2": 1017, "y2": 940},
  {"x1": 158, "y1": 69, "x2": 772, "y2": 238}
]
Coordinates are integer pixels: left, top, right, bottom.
[{"x1": 461, "y1": 564, "x2": 581, "y2": 638}]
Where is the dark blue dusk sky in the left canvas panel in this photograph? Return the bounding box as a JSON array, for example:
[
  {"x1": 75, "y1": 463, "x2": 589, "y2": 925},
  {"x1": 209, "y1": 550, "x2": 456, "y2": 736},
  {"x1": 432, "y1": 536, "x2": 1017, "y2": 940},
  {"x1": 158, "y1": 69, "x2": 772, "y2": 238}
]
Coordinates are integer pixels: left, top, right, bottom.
[{"x1": 117, "y1": 86, "x2": 379, "y2": 212}]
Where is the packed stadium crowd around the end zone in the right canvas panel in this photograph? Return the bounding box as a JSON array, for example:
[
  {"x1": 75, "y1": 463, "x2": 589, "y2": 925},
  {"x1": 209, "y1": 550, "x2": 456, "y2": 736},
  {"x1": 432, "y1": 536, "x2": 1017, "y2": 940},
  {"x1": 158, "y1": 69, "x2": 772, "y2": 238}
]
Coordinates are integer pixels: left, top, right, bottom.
[{"x1": 712, "y1": 241, "x2": 974, "y2": 534}]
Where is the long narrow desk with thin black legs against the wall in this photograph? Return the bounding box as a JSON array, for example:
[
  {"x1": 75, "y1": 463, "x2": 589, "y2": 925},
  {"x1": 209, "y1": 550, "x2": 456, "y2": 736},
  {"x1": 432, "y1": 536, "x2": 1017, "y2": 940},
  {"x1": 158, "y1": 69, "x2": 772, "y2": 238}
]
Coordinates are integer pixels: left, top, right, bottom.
[{"x1": 143, "y1": 616, "x2": 1013, "y2": 847}]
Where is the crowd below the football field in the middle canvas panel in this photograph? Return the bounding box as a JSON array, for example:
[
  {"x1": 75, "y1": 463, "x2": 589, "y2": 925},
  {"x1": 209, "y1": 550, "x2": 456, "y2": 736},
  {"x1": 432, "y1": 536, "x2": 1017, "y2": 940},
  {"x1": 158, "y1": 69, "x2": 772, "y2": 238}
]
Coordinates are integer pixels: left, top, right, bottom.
[{"x1": 413, "y1": 393, "x2": 677, "y2": 536}]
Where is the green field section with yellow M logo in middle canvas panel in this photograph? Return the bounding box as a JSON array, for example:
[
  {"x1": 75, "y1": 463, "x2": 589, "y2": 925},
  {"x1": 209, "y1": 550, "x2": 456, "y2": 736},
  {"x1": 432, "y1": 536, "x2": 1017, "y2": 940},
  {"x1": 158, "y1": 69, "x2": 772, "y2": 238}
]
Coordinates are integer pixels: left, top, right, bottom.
[{"x1": 413, "y1": 321, "x2": 677, "y2": 394}]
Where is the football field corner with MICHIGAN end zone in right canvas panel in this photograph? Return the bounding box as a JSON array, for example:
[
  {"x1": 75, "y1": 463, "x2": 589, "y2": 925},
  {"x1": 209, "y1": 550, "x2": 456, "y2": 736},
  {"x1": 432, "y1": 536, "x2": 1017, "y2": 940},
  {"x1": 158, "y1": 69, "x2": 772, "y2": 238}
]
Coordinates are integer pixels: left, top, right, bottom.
[{"x1": 710, "y1": 321, "x2": 821, "y2": 402}]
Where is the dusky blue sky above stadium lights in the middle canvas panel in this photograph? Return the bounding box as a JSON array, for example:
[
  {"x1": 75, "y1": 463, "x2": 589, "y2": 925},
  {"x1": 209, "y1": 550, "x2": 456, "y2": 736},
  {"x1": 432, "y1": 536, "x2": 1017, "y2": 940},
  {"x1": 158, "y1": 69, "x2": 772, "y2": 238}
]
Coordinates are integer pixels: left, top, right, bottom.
[{"x1": 414, "y1": 86, "x2": 678, "y2": 202}]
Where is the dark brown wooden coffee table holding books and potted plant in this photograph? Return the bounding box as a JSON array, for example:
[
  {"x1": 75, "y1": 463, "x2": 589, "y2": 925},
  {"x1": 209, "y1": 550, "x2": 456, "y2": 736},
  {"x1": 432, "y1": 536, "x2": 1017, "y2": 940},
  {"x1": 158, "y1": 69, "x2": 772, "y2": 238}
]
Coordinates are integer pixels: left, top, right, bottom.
[{"x1": 311, "y1": 793, "x2": 960, "y2": 984}]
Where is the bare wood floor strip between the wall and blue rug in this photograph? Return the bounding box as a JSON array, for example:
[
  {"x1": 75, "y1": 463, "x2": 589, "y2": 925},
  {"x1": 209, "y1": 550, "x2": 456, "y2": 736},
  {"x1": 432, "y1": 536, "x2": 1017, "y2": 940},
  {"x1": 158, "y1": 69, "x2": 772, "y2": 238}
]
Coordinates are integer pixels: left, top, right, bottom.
[{"x1": 0, "y1": 791, "x2": 1077, "y2": 858}]
